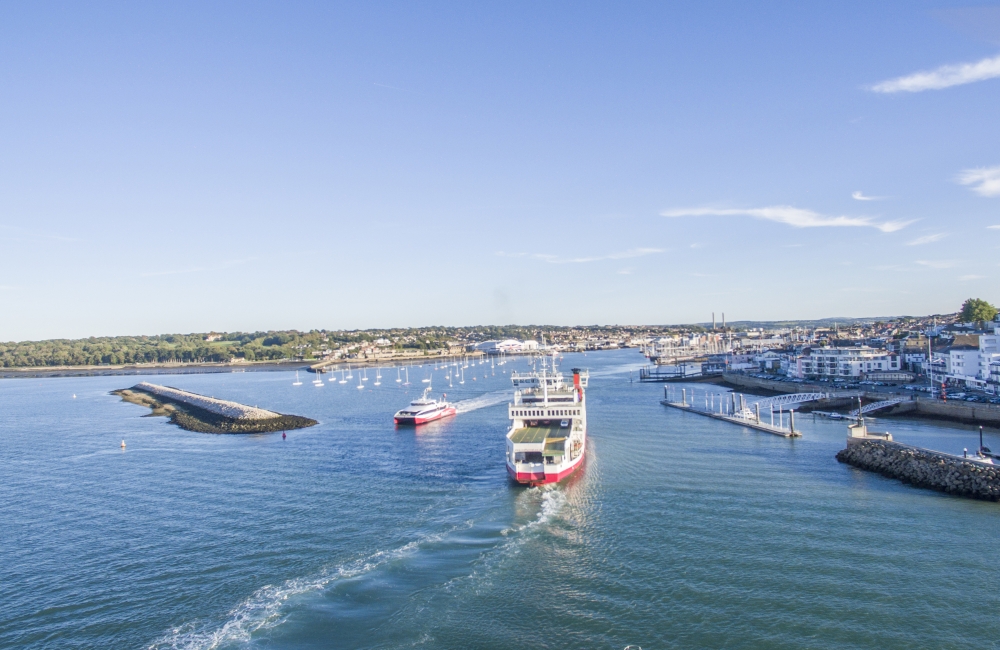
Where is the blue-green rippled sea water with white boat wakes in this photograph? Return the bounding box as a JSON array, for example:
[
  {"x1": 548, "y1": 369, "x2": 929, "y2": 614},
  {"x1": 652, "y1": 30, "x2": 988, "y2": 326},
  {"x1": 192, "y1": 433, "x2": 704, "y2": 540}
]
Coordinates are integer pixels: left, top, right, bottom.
[{"x1": 0, "y1": 351, "x2": 1000, "y2": 650}]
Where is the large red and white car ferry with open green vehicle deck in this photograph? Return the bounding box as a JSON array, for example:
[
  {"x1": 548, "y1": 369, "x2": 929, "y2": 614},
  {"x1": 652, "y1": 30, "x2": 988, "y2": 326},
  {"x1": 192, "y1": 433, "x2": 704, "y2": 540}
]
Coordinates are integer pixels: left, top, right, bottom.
[{"x1": 507, "y1": 359, "x2": 589, "y2": 486}]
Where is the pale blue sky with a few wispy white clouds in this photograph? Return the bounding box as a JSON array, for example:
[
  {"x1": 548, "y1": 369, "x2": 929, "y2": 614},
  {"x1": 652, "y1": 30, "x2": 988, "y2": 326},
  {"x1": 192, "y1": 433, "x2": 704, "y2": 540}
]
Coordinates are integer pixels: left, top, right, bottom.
[{"x1": 0, "y1": 0, "x2": 1000, "y2": 340}]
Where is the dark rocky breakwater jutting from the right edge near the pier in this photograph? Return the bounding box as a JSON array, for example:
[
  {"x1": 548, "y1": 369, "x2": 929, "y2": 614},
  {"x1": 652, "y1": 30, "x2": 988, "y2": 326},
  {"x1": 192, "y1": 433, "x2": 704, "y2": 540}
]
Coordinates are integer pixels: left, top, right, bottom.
[{"x1": 837, "y1": 440, "x2": 1000, "y2": 501}]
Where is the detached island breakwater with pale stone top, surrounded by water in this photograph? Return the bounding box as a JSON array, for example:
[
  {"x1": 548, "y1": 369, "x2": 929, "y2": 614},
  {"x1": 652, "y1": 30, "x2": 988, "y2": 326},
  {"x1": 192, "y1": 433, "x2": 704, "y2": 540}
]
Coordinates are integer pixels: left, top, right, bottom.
[{"x1": 113, "y1": 382, "x2": 316, "y2": 433}]
